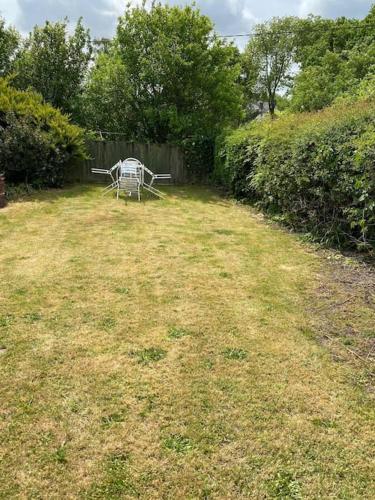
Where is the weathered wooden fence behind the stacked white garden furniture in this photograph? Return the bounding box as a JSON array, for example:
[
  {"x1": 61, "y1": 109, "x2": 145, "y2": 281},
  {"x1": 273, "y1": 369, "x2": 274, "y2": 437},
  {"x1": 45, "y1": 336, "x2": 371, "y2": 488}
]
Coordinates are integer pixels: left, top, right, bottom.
[{"x1": 67, "y1": 141, "x2": 188, "y2": 184}]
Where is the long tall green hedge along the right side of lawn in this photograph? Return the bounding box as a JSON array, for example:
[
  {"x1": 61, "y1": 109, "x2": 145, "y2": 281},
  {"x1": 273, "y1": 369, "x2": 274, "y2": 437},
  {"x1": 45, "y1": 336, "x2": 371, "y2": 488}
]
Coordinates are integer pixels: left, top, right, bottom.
[{"x1": 216, "y1": 99, "x2": 375, "y2": 248}]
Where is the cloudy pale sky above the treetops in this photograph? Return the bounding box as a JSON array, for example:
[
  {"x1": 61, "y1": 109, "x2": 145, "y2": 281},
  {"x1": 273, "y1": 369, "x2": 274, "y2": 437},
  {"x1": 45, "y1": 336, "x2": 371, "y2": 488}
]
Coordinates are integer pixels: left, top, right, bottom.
[{"x1": 0, "y1": 0, "x2": 375, "y2": 37}]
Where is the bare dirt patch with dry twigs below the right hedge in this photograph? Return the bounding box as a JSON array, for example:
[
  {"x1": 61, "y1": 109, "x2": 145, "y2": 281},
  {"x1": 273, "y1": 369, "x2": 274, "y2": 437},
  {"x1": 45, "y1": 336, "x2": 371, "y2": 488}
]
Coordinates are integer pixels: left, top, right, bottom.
[{"x1": 309, "y1": 251, "x2": 375, "y2": 388}]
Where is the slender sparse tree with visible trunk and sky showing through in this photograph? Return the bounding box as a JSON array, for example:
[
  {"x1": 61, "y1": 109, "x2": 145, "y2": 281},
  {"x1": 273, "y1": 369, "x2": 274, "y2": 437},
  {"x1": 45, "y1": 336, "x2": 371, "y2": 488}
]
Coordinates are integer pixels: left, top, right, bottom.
[{"x1": 243, "y1": 17, "x2": 297, "y2": 117}]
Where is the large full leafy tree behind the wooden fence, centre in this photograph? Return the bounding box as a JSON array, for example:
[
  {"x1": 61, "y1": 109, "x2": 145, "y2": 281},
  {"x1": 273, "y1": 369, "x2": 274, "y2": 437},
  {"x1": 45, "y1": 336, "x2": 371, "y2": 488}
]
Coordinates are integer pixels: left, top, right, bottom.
[{"x1": 101, "y1": 3, "x2": 242, "y2": 142}]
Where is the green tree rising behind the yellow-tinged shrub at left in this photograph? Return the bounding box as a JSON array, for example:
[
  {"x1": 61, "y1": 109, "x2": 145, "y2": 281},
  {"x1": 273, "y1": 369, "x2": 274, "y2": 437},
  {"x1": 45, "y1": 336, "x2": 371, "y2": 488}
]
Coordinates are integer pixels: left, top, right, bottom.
[{"x1": 14, "y1": 19, "x2": 92, "y2": 115}]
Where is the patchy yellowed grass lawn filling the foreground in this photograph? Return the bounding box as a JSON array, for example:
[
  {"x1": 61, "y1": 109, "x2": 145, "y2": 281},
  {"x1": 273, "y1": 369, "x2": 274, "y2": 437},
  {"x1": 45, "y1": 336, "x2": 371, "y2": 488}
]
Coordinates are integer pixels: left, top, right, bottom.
[{"x1": 0, "y1": 187, "x2": 375, "y2": 499}]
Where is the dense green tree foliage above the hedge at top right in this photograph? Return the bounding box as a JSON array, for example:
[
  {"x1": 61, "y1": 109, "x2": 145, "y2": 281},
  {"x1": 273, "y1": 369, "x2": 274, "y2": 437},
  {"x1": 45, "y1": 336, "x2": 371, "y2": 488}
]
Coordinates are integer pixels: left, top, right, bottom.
[{"x1": 291, "y1": 11, "x2": 375, "y2": 111}]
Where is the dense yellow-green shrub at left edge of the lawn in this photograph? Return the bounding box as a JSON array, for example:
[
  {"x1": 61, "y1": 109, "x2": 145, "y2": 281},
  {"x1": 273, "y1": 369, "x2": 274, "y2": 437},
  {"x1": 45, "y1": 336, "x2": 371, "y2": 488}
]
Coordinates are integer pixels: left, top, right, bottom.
[{"x1": 0, "y1": 79, "x2": 85, "y2": 187}]
